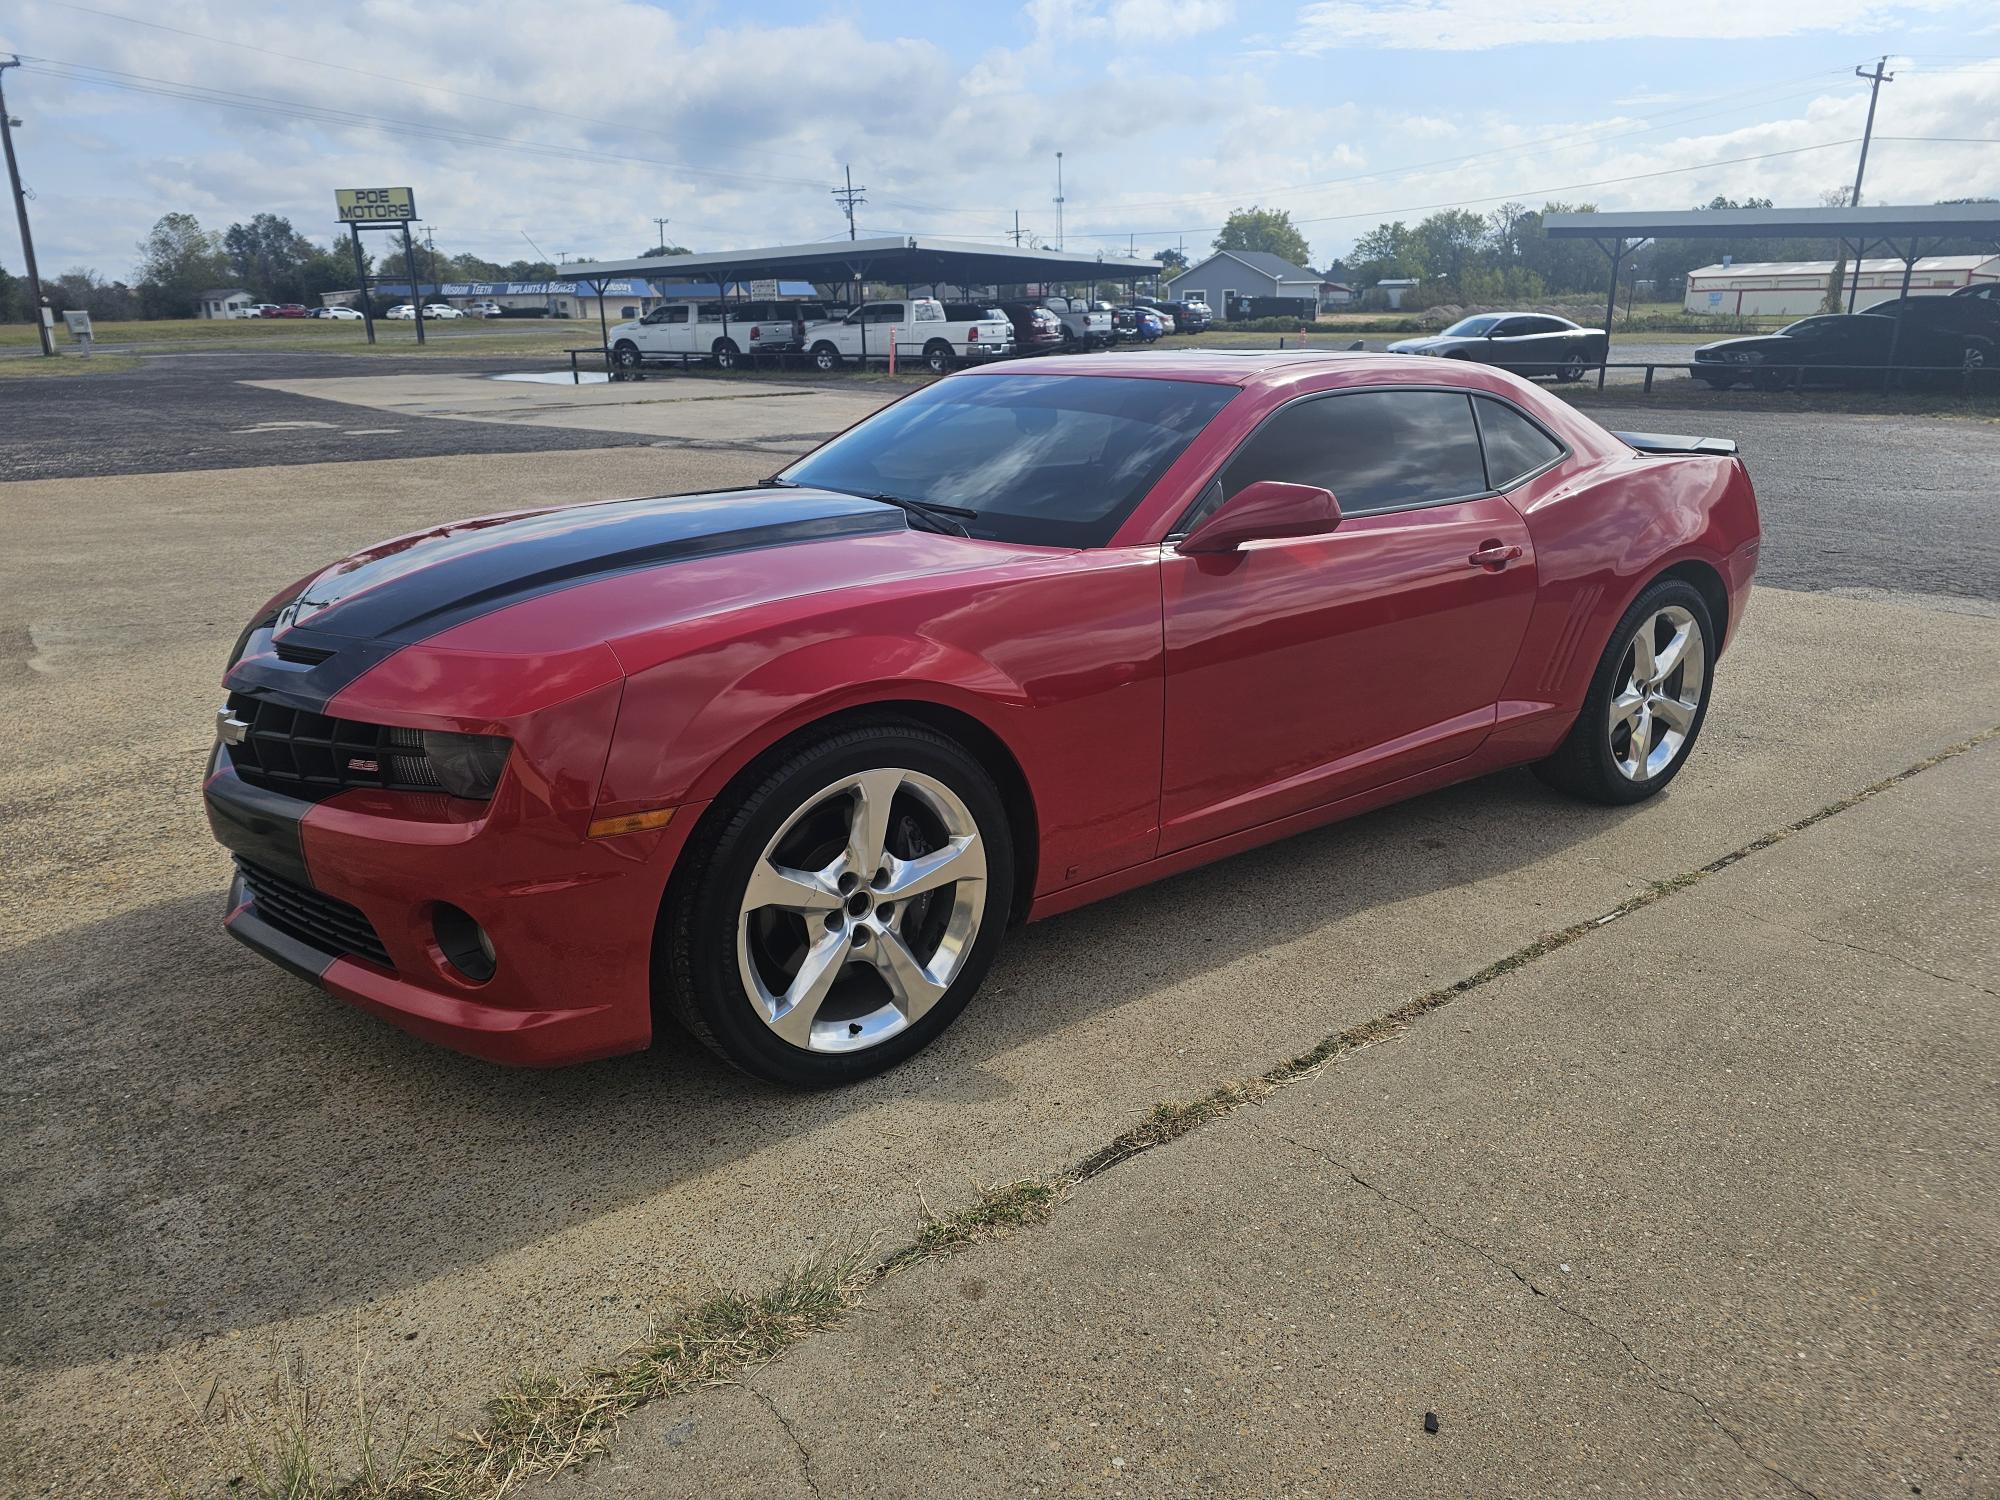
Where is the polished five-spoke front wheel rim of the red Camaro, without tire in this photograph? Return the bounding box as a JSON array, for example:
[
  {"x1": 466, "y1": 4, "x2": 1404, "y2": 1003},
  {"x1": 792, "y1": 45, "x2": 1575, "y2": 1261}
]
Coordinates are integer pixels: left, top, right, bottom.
[{"x1": 736, "y1": 768, "x2": 986, "y2": 1052}]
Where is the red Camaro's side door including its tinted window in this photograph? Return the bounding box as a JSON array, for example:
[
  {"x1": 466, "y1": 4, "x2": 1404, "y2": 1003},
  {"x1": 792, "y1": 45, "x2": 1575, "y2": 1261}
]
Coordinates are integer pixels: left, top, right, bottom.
[{"x1": 1160, "y1": 388, "x2": 1534, "y2": 854}]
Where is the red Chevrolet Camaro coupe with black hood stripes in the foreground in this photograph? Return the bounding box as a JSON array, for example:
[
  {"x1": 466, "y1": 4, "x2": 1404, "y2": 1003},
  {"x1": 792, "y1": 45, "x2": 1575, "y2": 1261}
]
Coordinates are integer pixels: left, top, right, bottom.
[{"x1": 204, "y1": 354, "x2": 1758, "y2": 1084}]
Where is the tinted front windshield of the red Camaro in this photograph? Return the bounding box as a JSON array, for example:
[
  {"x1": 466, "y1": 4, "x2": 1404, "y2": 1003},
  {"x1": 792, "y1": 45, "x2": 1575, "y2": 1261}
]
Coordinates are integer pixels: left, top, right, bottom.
[{"x1": 782, "y1": 374, "x2": 1236, "y2": 546}]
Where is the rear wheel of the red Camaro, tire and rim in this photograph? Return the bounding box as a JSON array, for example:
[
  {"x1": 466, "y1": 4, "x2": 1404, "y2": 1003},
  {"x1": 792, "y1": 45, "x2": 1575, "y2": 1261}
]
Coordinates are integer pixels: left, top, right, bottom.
[{"x1": 1534, "y1": 578, "x2": 1720, "y2": 806}]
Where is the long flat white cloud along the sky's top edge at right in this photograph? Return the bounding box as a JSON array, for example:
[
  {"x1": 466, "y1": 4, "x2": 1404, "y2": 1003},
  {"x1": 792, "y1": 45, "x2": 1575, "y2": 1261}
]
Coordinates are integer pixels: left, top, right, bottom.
[{"x1": 1298, "y1": 0, "x2": 1954, "y2": 52}]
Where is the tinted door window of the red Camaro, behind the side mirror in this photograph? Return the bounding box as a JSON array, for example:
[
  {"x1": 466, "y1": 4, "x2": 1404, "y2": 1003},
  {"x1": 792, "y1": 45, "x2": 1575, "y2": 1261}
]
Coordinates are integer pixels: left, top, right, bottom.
[{"x1": 1222, "y1": 390, "x2": 1486, "y2": 516}]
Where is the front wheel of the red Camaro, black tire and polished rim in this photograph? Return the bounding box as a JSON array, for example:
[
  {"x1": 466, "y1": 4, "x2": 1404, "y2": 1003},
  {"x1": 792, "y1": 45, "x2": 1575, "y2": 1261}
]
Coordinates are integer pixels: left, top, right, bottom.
[{"x1": 654, "y1": 720, "x2": 1014, "y2": 1088}]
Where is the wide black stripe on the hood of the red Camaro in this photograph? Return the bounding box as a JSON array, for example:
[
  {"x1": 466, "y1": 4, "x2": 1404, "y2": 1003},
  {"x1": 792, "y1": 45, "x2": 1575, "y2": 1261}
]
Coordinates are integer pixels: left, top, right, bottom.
[{"x1": 228, "y1": 490, "x2": 908, "y2": 710}]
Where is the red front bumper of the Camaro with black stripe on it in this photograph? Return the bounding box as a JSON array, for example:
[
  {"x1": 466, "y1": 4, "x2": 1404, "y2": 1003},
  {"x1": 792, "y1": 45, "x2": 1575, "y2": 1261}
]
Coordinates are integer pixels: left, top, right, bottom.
[{"x1": 202, "y1": 754, "x2": 700, "y2": 1066}]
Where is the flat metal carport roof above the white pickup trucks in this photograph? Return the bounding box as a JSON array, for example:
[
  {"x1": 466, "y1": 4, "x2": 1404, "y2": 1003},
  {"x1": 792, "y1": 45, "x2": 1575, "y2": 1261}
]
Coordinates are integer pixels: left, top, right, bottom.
[{"x1": 562, "y1": 234, "x2": 1160, "y2": 286}]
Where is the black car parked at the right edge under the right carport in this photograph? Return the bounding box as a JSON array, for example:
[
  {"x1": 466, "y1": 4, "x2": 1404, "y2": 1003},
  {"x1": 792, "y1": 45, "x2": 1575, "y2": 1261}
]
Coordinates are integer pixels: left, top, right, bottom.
[{"x1": 1694, "y1": 312, "x2": 1994, "y2": 390}]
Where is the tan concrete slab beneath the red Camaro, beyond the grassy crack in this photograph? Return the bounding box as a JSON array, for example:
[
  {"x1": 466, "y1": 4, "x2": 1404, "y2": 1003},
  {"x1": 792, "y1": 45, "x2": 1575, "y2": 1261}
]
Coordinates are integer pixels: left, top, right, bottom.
[{"x1": 0, "y1": 418, "x2": 2000, "y2": 1496}]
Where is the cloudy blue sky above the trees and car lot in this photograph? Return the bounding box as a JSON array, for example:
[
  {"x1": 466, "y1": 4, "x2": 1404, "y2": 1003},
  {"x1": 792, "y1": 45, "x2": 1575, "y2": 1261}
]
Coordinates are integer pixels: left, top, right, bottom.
[{"x1": 0, "y1": 0, "x2": 2000, "y2": 276}]
